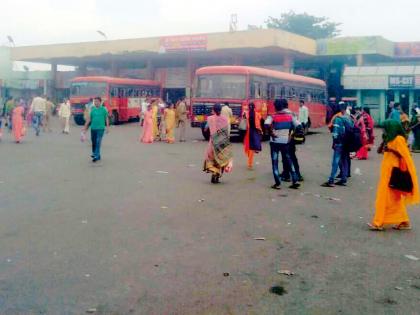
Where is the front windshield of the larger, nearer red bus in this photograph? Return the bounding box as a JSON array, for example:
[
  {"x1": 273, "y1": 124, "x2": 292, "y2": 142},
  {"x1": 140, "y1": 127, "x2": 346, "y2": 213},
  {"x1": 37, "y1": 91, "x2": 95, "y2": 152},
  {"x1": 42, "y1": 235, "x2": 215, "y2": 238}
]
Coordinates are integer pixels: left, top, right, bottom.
[{"x1": 195, "y1": 74, "x2": 246, "y2": 100}]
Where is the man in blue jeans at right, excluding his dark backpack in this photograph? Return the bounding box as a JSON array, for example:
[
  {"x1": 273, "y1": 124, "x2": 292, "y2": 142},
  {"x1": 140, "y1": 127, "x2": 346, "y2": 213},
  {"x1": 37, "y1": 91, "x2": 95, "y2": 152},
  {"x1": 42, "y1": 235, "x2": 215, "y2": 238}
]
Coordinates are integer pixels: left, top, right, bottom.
[{"x1": 321, "y1": 103, "x2": 351, "y2": 187}]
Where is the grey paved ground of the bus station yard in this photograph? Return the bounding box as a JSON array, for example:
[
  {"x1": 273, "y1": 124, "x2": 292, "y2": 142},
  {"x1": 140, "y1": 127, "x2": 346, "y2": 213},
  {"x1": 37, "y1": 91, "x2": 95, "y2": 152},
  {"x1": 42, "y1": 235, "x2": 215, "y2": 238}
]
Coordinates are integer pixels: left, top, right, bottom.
[{"x1": 0, "y1": 119, "x2": 420, "y2": 314}]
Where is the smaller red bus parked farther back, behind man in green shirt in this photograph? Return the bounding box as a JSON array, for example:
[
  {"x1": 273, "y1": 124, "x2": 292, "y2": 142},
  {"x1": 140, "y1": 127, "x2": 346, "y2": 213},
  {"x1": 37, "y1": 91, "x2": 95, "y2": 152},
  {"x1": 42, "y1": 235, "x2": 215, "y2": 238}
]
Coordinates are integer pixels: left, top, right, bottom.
[{"x1": 70, "y1": 77, "x2": 162, "y2": 125}]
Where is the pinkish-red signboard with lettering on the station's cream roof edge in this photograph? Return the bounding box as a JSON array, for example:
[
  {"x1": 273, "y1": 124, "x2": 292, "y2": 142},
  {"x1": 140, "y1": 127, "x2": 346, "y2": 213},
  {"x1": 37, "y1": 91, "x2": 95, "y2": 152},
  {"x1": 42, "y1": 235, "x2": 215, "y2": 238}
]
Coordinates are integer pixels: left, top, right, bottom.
[{"x1": 159, "y1": 35, "x2": 207, "y2": 53}]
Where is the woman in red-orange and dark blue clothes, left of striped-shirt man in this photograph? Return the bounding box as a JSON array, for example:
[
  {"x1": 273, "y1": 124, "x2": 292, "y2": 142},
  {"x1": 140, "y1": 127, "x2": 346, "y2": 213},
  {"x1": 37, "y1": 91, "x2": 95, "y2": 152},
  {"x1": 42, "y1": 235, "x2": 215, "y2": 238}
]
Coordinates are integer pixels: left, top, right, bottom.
[{"x1": 244, "y1": 103, "x2": 262, "y2": 170}]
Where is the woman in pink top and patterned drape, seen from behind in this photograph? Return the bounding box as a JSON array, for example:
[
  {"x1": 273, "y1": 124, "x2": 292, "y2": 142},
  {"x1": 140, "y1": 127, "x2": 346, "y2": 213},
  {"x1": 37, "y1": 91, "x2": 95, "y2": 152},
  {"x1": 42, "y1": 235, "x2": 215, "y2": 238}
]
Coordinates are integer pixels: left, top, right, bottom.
[{"x1": 203, "y1": 104, "x2": 232, "y2": 184}]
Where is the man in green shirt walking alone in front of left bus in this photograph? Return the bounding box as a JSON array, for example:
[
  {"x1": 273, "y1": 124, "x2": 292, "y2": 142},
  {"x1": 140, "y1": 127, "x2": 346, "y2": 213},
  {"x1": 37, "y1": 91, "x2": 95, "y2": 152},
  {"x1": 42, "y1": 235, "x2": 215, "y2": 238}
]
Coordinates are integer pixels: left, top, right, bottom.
[{"x1": 83, "y1": 96, "x2": 109, "y2": 163}]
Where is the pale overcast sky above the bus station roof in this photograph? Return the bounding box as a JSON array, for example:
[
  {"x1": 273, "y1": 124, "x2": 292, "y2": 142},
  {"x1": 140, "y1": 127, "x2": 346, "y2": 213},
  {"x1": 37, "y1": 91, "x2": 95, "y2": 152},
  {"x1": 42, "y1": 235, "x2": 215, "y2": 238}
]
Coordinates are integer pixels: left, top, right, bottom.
[{"x1": 0, "y1": 0, "x2": 420, "y2": 46}]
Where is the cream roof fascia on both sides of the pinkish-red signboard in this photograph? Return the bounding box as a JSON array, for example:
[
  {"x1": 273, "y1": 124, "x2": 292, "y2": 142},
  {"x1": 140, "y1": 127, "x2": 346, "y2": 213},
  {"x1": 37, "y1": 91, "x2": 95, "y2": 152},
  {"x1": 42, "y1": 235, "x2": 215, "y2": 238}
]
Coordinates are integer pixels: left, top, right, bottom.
[{"x1": 12, "y1": 29, "x2": 316, "y2": 62}]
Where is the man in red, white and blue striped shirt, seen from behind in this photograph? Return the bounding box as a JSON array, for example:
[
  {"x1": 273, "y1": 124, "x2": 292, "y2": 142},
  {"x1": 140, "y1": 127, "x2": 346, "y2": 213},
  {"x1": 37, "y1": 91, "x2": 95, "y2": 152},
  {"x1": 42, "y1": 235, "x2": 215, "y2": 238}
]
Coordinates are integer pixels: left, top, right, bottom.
[{"x1": 264, "y1": 99, "x2": 300, "y2": 189}]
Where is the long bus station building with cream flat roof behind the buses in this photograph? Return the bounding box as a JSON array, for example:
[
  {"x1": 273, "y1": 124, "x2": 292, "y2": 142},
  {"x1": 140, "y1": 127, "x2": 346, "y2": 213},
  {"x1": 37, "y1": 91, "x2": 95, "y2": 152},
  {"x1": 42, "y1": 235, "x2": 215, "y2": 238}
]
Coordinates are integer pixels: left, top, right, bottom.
[{"x1": 0, "y1": 29, "x2": 420, "y2": 122}]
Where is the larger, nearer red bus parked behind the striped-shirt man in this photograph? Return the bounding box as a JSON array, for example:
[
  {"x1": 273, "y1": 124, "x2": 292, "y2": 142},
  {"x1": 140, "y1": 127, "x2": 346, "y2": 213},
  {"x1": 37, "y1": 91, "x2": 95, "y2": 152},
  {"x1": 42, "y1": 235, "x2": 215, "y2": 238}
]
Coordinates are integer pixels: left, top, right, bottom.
[{"x1": 191, "y1": 66, "x2": 327, "y2": 138}]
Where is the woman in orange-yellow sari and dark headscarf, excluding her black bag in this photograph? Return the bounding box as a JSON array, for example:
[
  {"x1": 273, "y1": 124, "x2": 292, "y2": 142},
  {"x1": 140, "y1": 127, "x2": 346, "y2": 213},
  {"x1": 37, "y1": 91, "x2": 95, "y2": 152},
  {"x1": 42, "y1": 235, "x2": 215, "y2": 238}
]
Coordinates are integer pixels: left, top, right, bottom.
[{"x1": 368, "y1": 120, "x2": 420, "y2": 231}]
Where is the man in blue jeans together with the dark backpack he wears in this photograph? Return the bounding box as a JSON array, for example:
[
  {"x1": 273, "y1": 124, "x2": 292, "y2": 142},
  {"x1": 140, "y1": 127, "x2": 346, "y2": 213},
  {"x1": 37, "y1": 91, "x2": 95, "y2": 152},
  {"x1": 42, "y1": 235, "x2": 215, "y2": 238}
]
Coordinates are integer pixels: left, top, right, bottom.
[{"x1": 321, "y1": 103, "x2": 360, "y2": 187}]
